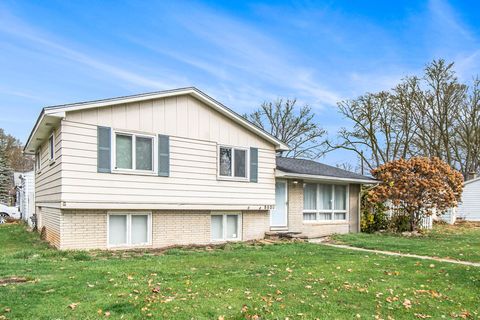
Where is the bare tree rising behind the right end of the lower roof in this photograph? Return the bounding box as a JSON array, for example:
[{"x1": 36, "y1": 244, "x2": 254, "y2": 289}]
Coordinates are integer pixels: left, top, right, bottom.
[{"x1": 327, "y1": 88, "x2": 414, "y2": 169}]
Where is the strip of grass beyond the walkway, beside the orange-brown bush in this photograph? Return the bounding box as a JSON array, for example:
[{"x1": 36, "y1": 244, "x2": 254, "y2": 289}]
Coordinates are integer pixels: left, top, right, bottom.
[{"x1": 333, "y1": 223, "x2": 480, "y2": 262}]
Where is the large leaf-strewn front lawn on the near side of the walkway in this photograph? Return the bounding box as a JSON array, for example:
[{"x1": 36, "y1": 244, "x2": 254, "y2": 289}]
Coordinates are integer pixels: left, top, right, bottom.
[{"x1": 0, "y1": 225, "x2": 480, "y2": 319}]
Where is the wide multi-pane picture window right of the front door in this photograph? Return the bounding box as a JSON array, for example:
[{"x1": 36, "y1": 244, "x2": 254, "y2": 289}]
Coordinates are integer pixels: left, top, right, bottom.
[{"x1": 303, "y1": 183, "x2": 348, "y2": 221}]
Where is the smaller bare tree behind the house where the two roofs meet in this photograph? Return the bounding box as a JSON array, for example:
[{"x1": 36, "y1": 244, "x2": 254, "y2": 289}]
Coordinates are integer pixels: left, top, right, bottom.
[{"x1": 244, "y1": 99, "x2": 326, "y2": 159}]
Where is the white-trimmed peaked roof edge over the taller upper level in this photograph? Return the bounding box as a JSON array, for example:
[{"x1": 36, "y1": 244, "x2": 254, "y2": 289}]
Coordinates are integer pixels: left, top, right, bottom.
[{"x1": 24, "y1": 87, "x2": 289, "y2": 153}]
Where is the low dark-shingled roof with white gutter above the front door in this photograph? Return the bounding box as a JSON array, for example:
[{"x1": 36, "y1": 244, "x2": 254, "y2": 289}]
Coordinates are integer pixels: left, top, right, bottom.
[{"x1": 277, "y1": 157, "x2": 379, "y2": 184}]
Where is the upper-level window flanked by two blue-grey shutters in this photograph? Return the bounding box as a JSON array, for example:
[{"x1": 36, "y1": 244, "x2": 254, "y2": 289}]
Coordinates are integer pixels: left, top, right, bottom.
[{"x1": 113, "y1": 132, "x2": 155, "y2": 172}]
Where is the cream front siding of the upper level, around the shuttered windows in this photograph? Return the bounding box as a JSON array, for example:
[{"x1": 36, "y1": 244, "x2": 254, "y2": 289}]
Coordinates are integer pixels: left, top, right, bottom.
[{"x1": 62, "y1": 96, "x2": 275, "y2": 210}]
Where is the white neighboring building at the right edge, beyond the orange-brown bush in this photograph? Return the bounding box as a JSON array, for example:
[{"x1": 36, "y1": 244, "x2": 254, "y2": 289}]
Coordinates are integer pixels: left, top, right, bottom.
[{"x1": 456, "y1": 178, "x2": 480, "y2": 221}]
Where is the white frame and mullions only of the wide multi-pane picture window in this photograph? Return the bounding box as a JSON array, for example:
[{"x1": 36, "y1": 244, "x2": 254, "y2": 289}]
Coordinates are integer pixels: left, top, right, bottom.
[{"x1": 302, "y1": 181, "x2": 350, "y2": 223}]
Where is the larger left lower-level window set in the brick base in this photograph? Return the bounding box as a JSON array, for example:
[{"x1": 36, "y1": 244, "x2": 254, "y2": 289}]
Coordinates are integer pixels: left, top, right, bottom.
[{"x1": 108, "y1": 213, "x2": 151, "y2": 247}]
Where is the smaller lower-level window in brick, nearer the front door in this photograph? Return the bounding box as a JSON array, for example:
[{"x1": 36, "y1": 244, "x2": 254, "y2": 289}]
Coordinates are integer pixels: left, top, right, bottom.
[{"x1": 210, "y1": 213, "x2": 241, "y2": 241}]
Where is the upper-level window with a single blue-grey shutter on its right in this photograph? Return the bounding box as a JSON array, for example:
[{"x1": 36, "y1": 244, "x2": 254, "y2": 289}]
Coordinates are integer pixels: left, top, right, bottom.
[{"x1": 218, "y1": 146, "x2": 248, "y2": 179}]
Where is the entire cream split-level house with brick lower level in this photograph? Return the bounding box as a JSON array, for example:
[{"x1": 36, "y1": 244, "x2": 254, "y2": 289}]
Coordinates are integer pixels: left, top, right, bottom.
[{"x1": 25, "y1": 88, "x2": 373, "y2": 249}]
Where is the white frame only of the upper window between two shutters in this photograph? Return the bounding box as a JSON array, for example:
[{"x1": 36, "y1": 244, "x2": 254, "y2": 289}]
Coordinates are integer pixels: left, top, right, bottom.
[{"x1": 111, "y1": 129, "x2": 158, "y2": 175}]
